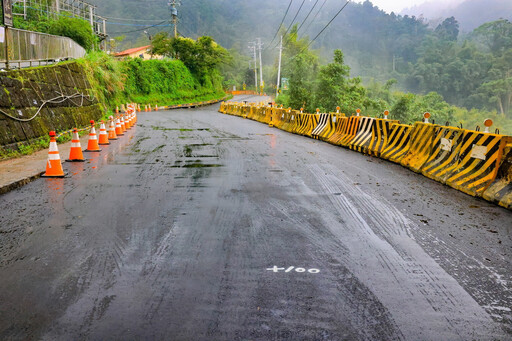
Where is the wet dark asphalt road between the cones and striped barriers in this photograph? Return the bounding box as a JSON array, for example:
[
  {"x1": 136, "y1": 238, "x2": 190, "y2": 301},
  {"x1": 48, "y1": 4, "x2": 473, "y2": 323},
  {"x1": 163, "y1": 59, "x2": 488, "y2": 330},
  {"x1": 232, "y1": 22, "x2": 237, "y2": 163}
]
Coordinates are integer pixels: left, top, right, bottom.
[{"x1": 0, "y1": 97, "x2": 512, "y2": 340}]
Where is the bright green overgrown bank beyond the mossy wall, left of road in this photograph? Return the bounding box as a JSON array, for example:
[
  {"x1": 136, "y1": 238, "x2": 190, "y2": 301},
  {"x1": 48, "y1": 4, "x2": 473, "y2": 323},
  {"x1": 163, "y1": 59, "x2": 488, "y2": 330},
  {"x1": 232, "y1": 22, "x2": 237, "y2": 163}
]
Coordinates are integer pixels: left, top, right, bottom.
[{"x1": 80, "y1": 43, "x2": 225, "y2": 108}]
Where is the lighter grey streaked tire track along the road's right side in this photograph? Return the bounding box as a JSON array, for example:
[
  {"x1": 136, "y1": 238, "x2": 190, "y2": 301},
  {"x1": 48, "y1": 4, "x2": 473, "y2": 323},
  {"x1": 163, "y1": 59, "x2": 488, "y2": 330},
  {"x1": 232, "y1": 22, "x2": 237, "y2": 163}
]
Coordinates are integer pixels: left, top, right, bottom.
[{"x1": 308, "y1": 164, "x2": 506, "y2": 340}]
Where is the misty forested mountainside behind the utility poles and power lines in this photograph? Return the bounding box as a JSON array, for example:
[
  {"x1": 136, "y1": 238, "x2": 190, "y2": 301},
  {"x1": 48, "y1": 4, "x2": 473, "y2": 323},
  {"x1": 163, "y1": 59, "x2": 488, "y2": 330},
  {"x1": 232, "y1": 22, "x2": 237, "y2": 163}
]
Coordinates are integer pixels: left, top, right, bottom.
[{"x1": 92, "y1": 0, "x2": 512, "y2": 127}]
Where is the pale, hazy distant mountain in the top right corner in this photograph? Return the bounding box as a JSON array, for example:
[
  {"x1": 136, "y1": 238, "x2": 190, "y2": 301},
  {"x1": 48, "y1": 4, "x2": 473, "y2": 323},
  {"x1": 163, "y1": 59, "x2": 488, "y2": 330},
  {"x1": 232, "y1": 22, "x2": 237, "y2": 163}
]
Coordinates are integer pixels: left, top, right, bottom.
[{"x1": 401, "y1": 0, "x2": 512, "y2": 32}]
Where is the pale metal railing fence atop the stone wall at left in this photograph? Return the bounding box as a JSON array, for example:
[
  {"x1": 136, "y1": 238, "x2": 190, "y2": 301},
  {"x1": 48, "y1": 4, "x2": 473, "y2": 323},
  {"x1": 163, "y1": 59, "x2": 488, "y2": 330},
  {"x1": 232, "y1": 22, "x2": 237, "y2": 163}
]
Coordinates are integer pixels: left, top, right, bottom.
[{"x1": 0, "y1": 26, "x2": 86, "y2": 69}]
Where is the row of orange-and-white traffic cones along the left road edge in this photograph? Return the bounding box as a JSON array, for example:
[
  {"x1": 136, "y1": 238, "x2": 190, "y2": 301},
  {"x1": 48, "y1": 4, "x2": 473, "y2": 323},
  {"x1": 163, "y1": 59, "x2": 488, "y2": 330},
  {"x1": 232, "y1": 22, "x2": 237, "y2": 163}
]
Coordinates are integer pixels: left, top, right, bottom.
[{"x1": 43, "y1": 104, "x2": 137, "y2": 178}]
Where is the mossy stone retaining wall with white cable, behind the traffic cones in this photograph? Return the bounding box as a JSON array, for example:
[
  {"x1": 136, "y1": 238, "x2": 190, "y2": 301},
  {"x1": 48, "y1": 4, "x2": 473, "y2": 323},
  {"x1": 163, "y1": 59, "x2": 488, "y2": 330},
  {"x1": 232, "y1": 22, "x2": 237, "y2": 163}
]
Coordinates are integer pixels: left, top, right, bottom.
[{"x1": 0, "y1": 62, "x2": 104, "y2": 149}]
